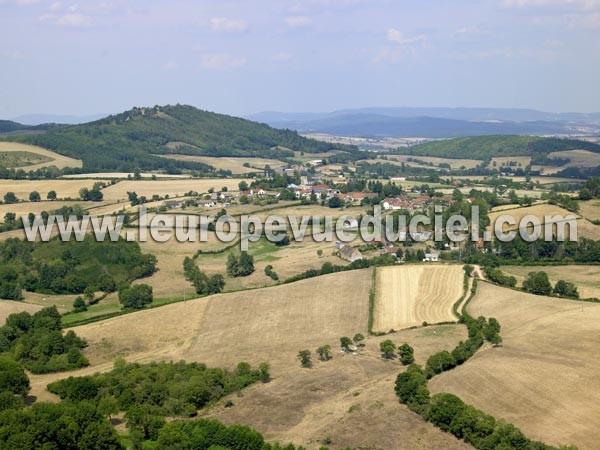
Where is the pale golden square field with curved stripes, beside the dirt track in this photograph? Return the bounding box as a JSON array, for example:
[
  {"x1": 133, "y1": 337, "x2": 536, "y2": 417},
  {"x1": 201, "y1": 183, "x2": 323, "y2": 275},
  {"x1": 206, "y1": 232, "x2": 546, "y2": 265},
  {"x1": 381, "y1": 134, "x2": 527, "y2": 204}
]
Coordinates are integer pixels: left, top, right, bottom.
[{"x1": 373, "y1": 265, "x2": 463, "y2": 331}]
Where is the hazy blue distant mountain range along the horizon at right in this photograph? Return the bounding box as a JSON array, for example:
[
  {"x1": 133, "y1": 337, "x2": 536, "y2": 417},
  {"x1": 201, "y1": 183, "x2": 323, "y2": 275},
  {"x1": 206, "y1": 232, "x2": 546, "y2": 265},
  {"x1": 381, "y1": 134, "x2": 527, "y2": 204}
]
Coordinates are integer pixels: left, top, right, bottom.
[{"x1": 248, "y1": 107, "x2": 600, "y2": 138}]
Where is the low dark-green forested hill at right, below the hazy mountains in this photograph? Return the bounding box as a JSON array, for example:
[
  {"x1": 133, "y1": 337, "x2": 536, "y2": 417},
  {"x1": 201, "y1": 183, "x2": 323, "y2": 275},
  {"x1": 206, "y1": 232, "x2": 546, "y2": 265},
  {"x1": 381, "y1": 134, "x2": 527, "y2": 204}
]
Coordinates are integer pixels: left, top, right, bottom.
[{"x1": 399, "y1": 135, "x2": 600, "y2": 161}]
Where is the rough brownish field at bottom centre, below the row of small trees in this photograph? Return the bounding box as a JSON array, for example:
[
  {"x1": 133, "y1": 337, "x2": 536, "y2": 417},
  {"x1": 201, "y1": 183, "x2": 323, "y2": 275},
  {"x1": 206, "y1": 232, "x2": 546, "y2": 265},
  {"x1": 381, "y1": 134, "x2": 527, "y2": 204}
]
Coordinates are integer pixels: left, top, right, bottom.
[{"x1": 209, "y1": 325, "x2": 471, "y2": 450}]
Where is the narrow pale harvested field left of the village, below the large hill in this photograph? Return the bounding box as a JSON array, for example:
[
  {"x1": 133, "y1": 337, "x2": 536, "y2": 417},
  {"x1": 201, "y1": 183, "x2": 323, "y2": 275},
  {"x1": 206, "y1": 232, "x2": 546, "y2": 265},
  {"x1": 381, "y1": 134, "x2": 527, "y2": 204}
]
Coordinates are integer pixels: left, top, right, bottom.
[{"x1": 101, "y1": 178, "x2": 250, "y2": 201}]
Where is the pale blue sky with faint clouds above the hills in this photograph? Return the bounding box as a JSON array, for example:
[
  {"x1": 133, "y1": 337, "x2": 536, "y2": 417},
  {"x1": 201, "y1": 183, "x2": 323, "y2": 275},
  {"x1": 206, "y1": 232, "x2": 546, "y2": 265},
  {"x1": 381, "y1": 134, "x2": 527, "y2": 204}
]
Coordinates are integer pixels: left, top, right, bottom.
[{"x1": 0, "y1": 0, "x2": 600, "y2": 118}]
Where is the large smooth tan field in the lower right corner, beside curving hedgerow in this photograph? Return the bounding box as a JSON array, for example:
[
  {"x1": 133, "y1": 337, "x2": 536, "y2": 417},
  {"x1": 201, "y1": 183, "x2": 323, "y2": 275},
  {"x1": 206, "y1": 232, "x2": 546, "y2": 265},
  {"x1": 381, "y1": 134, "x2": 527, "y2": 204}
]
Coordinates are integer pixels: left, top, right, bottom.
[{"x1": 429, "y1": 283, "x2": 600, "y2": 450}]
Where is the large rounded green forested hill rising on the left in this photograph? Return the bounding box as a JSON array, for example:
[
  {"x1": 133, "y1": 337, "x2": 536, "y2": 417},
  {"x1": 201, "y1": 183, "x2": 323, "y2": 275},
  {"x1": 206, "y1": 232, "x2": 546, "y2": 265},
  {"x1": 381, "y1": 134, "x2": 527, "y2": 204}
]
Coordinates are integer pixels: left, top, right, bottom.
[{"x1": 5, "y1": 105, "x2": 358, "y2": 171}]
